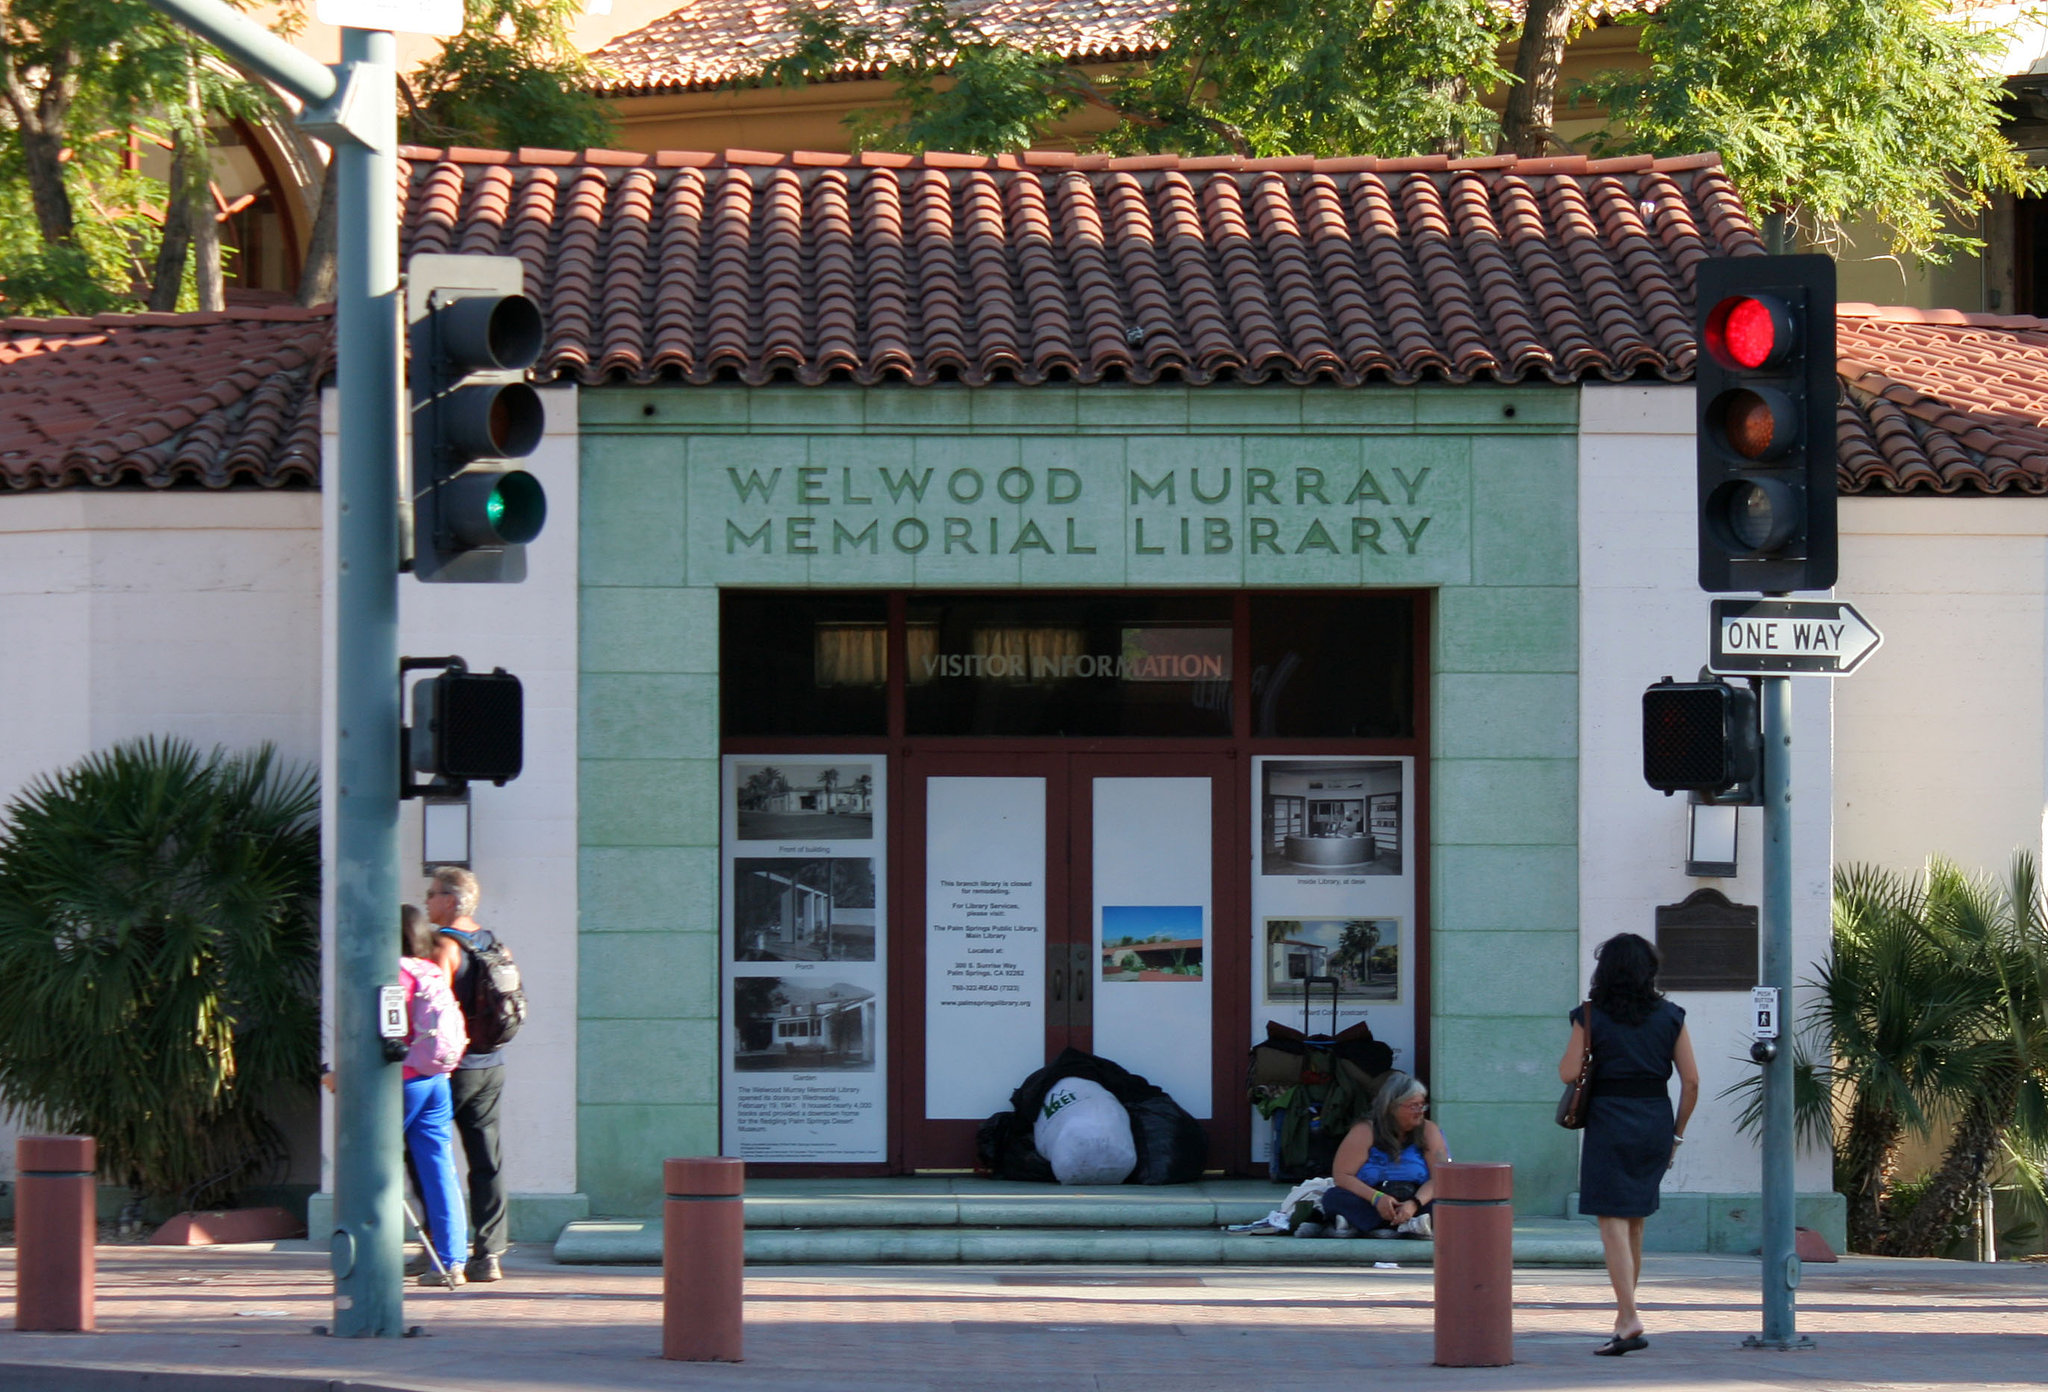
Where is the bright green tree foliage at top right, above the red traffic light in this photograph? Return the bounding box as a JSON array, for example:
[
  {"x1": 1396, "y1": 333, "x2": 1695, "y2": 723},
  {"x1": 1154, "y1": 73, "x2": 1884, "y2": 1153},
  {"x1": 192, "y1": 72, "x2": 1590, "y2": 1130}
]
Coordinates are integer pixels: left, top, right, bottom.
[{"x1": 1583, "y1": 0, "x2": 2044, "y2": 260}]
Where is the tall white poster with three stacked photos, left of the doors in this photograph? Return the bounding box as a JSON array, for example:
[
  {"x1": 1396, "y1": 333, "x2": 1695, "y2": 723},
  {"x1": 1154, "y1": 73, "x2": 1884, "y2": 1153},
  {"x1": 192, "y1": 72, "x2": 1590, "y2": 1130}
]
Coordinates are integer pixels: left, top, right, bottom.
[{"x1": 719, "y1": 753, "x2": 889, "y2": 1163}]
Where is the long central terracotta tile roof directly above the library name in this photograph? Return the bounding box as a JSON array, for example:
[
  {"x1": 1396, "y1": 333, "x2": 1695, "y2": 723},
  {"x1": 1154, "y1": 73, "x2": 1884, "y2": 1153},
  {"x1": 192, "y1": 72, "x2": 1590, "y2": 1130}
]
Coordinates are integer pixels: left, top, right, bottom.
[{"x1": 403, "y1": 147, "x2": 1761, "y2": 385}]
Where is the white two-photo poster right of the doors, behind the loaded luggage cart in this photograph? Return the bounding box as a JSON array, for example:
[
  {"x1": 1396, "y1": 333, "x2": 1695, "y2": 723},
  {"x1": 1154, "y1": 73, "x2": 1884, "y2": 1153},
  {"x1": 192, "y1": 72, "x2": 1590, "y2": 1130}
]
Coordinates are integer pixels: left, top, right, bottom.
[{"x1": 1251, "y1": 755, "x2": 1427, "y2": 1161}]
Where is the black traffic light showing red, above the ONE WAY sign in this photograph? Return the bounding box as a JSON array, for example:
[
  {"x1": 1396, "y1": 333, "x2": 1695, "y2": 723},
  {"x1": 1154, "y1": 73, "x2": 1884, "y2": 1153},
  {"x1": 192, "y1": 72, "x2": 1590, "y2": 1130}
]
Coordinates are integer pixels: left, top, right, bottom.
[{"x1": 1694, "y1": 256, "x2": 1839, "y2": 594}]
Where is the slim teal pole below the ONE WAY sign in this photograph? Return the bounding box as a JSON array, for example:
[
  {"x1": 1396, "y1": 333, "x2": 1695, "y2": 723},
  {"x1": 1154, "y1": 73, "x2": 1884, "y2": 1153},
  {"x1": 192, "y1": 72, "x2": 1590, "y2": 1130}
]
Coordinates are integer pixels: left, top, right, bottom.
[{"x1": 1743, "y1": 678, "x2": 1812, "y2": 1349}]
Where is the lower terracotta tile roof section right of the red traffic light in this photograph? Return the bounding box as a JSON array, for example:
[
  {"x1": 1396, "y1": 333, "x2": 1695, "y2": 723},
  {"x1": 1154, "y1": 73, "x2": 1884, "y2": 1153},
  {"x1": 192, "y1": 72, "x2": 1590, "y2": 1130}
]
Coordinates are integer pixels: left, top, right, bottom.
[{"x1": 1837, "y1": 305, "x2": 2048, "y2": 495}]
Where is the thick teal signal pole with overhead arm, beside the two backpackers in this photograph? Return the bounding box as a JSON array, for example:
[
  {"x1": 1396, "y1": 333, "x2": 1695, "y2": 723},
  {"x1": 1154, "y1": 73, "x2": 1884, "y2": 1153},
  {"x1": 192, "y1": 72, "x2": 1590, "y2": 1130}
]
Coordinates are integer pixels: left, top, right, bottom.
[{"x1": 140, "y1": 0, "x2": 406, "y2": 1339}]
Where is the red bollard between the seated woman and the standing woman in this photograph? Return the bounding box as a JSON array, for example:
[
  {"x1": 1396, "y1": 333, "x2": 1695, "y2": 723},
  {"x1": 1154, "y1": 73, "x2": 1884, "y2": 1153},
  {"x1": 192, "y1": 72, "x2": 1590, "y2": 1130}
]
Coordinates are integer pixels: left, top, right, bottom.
[{"x1": 1430, "y1": 1165, "x2": 1516, "y2": 1367}]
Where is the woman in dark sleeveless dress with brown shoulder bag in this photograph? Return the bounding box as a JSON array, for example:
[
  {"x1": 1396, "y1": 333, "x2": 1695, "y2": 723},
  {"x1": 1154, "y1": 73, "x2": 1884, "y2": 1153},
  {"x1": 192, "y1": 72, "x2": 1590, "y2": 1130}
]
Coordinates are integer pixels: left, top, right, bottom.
[{"x1": 1556, "y1": 933, "x2": 1700, "y2": 1357}]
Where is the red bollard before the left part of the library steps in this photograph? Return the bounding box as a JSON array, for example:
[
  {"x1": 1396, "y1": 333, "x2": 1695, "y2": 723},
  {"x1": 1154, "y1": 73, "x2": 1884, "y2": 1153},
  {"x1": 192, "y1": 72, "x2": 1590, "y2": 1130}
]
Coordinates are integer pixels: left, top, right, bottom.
[{"x1": 662, "y1": 1157, "x2": 748, "y2": 1363}]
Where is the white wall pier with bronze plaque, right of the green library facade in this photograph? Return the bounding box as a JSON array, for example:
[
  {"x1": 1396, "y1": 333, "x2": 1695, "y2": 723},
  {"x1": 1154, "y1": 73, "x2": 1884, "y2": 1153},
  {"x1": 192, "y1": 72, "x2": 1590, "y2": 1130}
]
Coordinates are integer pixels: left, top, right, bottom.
[{"x1": 1559, "y1": 385, "x2": 1835, "y2": 1193}]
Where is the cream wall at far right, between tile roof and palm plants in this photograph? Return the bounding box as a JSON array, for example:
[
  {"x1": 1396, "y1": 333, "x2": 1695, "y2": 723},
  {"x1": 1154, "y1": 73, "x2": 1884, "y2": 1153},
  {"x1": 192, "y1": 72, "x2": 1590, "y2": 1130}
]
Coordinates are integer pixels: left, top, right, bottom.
[{"x1": 1835, "y1": 497, "x2": 2048, "y2": 874}]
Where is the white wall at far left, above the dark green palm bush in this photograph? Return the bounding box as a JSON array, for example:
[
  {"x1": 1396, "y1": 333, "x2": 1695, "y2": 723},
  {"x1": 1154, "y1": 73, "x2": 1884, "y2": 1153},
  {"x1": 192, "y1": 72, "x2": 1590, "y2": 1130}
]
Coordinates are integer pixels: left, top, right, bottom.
[{"x1": 0, "y1": 489, "x2": 319, "y2": 1181}]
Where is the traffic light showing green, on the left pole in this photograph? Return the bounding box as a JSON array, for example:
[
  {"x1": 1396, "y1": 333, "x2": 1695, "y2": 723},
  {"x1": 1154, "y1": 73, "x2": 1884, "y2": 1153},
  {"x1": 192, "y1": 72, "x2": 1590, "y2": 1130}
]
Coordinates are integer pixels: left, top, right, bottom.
[{"x1": 403, "y1": 254, "x2": 547, "y2": 583}]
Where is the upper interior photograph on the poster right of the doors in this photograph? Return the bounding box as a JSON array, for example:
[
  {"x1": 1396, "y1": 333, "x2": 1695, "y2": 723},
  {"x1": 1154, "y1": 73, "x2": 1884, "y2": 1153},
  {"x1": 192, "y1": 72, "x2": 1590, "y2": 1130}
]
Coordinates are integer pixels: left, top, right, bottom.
[{"x1": 1260, "y1": 759, "x2": 1403, "y2": 876}]
